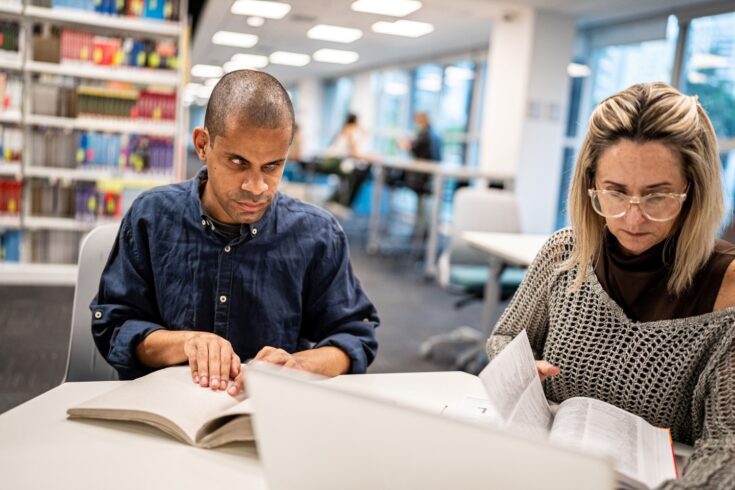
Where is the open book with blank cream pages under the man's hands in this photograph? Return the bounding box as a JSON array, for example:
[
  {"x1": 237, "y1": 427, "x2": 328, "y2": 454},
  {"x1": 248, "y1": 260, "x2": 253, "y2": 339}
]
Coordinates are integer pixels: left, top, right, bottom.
[{"x1": 66, "y1": 366, "x2": 254, "y2": 448}]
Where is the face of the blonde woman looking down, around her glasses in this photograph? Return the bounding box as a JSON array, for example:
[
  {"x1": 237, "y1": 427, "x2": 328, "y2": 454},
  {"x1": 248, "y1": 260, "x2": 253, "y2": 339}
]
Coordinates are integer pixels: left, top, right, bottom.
[{"x1": 595, "y1": 140, "x2": 687, "y2": 255}]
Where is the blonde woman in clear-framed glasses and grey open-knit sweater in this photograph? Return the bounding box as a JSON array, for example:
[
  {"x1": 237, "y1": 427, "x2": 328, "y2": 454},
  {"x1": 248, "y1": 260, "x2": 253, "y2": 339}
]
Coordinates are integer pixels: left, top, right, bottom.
[{"x1": 487, "y1": 83, "x2": 735, "y2": 489}]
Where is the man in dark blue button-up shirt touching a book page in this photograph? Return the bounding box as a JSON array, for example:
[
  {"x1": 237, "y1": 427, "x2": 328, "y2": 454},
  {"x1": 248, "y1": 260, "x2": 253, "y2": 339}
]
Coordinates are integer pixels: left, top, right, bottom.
[{"x1": 90, "y1": 70, "x2": 379, "y2": 395}]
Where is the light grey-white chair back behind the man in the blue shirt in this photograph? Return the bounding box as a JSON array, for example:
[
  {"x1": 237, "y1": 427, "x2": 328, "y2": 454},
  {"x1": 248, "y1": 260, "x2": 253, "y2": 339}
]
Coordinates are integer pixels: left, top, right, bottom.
[{"x1": 64, "y1": 224, "x2": 119, "y2": 382}]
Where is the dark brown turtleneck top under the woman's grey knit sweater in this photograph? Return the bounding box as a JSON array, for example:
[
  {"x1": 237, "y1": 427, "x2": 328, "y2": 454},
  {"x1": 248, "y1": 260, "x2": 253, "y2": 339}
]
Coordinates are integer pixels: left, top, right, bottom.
[{"x1": 595, "y1": 228, "x2": 735, "y2": 321}]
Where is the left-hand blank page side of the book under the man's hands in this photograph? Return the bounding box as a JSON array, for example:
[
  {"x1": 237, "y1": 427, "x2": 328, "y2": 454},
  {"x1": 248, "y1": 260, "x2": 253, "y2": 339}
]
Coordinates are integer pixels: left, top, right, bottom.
[{"x1": 67, "y1": 366, "x2": 248, "y2": 444}]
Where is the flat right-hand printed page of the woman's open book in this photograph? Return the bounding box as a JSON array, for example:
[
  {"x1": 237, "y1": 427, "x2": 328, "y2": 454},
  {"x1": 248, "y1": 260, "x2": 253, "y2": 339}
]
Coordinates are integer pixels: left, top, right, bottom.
[{"x1": 550, "y1": 397, "x2": 676, "y2": 488}]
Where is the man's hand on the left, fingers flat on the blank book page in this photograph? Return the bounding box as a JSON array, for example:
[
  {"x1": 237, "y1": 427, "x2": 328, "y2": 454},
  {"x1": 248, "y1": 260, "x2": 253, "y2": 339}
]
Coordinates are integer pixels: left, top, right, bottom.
[{"x1": 184, "y1": 332, "x2": 241, "y2": 394}]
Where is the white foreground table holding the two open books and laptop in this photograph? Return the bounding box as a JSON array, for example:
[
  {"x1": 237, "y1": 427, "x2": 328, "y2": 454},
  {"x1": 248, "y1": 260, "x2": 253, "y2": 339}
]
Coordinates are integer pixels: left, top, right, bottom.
[{"x1": 0, "y1": 372, "x2": 484, "y2": 490}]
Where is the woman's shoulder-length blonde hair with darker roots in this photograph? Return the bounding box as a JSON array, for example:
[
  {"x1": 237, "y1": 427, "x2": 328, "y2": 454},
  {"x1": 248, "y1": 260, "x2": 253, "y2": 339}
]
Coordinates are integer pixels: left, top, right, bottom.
[{"x1": 561, "y1": 82, "x2": 724, "y2": 295}]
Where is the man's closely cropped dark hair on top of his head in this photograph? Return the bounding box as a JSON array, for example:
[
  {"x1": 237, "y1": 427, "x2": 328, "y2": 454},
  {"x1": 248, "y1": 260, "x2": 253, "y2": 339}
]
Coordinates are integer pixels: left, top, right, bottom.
[{"x1": 204, "y1": 70, "x2": 294, "y2": 146}]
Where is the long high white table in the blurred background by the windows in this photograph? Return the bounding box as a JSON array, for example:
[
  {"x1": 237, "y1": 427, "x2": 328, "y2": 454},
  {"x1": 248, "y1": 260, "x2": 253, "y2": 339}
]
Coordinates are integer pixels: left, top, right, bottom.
[{"x1": 368, "y1": 158, "x2": 515, "y2": 277}]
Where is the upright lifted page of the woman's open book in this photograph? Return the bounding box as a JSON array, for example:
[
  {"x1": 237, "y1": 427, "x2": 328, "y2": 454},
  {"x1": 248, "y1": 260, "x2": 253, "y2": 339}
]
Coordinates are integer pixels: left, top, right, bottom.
[{"x1": 480, "y1": 330, "x2": 553, "y2": 438}]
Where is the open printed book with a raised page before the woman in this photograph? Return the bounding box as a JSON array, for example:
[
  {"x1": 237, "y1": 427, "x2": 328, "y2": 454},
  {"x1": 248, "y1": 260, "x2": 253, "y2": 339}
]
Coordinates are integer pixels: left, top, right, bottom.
[{"x1": 447, "y1": 330, "x2": 677, "y2": 489}]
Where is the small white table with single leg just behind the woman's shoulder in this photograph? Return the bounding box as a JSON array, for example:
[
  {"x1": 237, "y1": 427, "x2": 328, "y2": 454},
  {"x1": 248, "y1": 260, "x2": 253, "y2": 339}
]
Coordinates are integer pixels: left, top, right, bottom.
[{"x1": 462, "y1": 231, "x2": 549, "y2": 336}]
